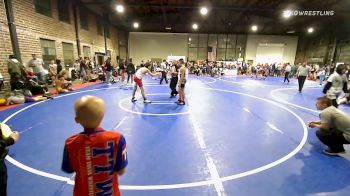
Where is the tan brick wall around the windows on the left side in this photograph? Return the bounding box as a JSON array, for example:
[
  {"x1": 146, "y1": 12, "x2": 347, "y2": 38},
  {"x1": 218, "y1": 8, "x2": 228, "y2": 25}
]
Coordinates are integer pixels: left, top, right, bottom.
[{"x1": 0, "y1": 0, "x2": 119, "y2": 89}]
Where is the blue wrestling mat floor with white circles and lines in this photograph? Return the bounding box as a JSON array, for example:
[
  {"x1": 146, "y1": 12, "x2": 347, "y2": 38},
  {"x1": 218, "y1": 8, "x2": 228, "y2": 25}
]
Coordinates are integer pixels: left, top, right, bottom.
[{"x1": 0, "y1": 76, "x2": 350, "y2": 196}]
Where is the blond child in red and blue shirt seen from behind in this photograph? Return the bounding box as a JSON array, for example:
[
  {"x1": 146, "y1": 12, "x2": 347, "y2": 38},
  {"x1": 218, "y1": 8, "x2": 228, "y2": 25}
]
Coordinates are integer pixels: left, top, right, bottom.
[{"x1": 62, "y1": 95, "x2": 128, "y2": 196}]
